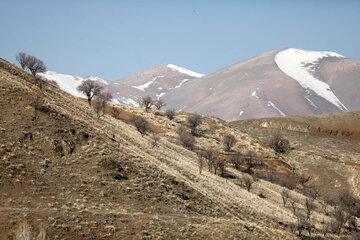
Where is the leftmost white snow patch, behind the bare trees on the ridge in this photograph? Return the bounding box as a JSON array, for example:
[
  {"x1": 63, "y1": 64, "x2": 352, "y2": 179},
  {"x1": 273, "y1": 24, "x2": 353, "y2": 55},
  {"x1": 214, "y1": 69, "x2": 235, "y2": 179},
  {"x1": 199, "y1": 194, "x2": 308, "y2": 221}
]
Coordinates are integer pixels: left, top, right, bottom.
[{"x1": 38, "y1": 71, "x2": 109, "y2": 97}]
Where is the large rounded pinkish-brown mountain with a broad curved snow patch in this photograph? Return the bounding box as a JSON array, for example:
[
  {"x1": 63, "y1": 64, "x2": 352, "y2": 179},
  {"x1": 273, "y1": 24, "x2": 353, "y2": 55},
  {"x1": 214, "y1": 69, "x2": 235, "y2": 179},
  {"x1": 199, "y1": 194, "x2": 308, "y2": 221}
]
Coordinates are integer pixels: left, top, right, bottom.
[{"x1": 164, "y1": 48, "x2": 360, "y2": 121}]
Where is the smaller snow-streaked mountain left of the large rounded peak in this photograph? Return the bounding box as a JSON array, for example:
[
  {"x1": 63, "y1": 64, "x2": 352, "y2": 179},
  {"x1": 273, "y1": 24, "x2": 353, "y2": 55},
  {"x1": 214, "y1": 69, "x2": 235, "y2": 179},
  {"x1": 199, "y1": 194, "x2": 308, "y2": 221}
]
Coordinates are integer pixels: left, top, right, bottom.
[{"x1": 39, "y1": 64, "x2": 204, "y2": 106}]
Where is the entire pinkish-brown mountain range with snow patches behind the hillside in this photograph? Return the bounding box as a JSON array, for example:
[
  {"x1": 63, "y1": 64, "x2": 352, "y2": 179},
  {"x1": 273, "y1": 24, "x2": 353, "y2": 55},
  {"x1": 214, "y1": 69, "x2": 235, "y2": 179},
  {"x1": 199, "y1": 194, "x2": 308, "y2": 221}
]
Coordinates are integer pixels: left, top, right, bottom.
[{"x1": 38, "y1": 48, "x2": 360, "y2": 121}]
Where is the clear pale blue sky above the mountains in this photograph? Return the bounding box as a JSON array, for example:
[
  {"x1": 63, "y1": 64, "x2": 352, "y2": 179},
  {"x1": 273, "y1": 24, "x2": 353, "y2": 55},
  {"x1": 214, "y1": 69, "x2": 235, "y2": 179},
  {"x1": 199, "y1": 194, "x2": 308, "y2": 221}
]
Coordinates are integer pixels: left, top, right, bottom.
[{"x1": 0, "y1": 0, "x2": 360, "y2": 80}]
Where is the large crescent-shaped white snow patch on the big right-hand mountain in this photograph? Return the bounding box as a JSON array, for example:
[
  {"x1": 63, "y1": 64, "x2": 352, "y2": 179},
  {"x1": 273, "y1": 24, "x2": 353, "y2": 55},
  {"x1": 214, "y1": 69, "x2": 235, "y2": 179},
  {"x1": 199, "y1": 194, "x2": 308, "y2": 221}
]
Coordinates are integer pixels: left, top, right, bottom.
[{"x1": 275, "y1": 48, "x2": 348, "y2": 111}]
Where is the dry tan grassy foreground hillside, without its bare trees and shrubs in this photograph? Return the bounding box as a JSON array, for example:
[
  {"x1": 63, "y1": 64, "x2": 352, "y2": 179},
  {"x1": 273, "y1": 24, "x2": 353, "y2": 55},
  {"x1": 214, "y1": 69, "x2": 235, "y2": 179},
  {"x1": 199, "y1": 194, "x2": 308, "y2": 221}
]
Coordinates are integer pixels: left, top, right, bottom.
[{"x1": 0, "y1": 59, "x2": 359, "y2": 239}]
